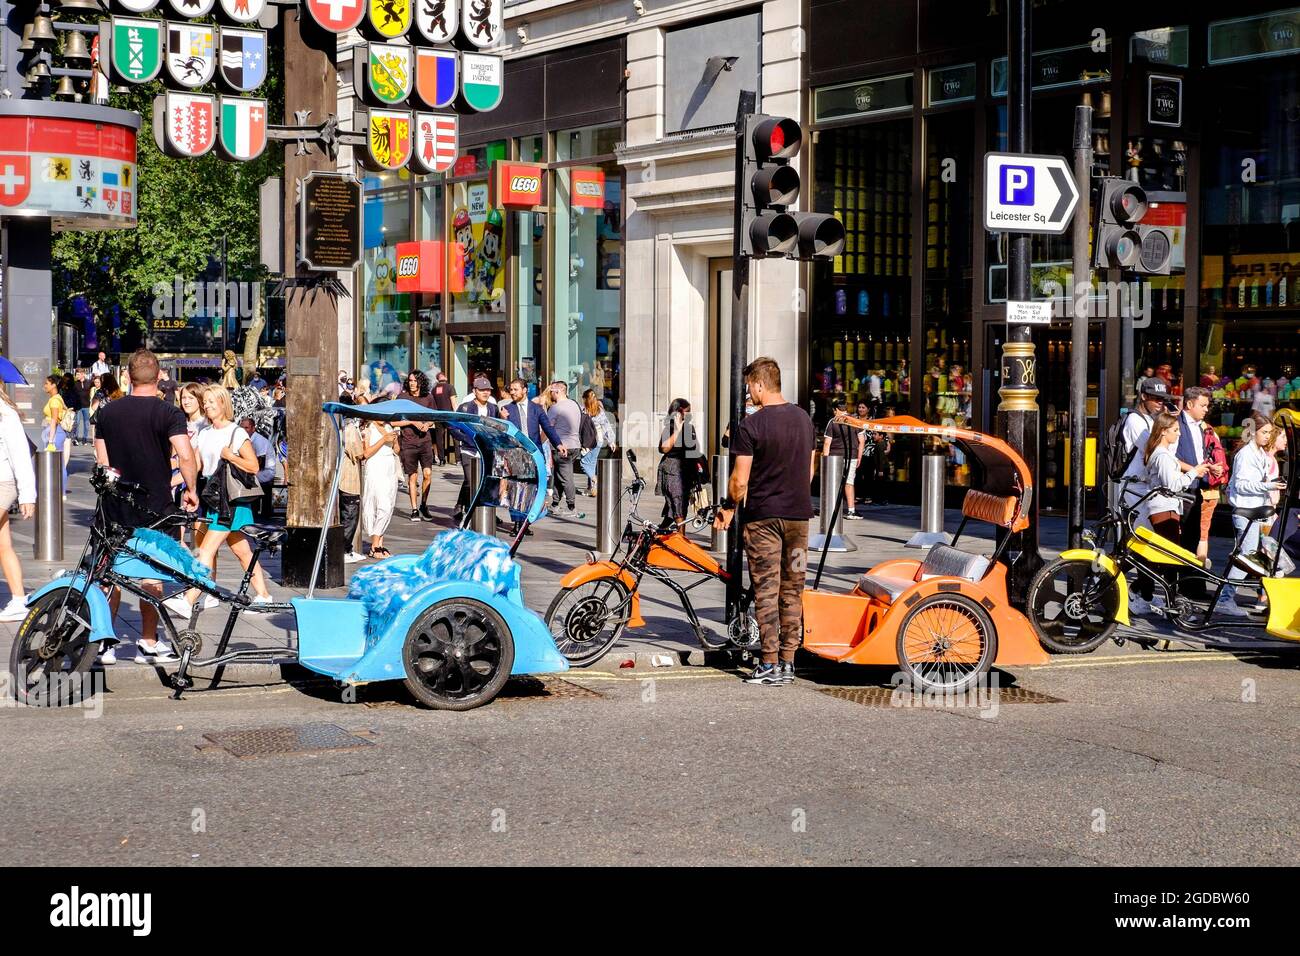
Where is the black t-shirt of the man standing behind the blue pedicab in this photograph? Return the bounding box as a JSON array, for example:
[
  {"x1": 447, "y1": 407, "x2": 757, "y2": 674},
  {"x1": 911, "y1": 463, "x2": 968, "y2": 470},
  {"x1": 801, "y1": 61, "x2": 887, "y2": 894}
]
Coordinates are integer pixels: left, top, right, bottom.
[{"x1": 95, "y1": 395, "x2": 186, "y2": 514}]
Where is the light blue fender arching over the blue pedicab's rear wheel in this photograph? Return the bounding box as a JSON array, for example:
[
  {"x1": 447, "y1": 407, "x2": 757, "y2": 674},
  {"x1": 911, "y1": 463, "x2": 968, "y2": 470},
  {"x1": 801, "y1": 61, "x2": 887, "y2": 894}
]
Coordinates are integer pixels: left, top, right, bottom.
[{"x1": 341, "y1": 580, "x2": 568, "y2": 683}]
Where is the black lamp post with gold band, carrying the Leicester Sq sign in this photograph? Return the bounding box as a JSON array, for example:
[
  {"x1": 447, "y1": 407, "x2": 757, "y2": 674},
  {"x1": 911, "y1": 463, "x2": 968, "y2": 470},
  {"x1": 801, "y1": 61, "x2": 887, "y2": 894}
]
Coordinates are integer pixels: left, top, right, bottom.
[{"x1": 997, "y1": 0, "x2": 1045, "y2": 594}]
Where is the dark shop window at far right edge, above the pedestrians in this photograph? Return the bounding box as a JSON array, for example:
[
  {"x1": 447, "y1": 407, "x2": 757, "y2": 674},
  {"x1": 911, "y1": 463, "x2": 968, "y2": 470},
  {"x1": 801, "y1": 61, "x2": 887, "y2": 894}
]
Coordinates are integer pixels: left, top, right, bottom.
[{"x1": 1197, "y1": 57, "x2": 1300, "y2": 431}]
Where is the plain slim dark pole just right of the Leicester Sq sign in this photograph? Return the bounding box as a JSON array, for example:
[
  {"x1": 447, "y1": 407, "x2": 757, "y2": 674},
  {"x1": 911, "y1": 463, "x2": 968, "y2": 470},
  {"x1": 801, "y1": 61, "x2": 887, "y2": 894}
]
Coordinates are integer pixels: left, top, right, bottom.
[{"x1": 1070, "y1": 107, "x2": 1092, "y2": 548}]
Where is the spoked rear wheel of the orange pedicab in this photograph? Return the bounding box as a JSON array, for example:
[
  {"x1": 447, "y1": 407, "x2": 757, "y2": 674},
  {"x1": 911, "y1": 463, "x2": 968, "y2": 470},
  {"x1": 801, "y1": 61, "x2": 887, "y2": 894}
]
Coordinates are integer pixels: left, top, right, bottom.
[{"x1": 897, "y1": 592, "x2": 997, "y2": 693}]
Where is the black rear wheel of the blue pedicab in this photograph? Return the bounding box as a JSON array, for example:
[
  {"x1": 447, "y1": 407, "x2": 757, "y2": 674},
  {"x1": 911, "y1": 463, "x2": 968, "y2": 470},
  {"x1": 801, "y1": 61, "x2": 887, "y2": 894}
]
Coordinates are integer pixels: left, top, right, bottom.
[{"x1": 402, "y1": 597, "x2": 515, "y2": 710}]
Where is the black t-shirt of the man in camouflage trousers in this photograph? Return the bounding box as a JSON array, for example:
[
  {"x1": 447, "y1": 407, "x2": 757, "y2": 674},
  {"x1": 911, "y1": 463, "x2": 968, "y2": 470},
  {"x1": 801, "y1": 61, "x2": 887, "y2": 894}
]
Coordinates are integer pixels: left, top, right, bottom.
[{"x1": 731, "y1": 402, "x2": 816, "y2": 522}]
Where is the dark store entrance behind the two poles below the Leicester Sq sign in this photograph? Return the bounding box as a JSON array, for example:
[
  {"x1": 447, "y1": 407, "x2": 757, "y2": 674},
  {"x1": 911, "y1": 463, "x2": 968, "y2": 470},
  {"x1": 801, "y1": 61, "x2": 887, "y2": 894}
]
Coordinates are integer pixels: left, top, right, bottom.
[{"x1": 980, "y1": 321, "x2": 1102, "y2": 514}]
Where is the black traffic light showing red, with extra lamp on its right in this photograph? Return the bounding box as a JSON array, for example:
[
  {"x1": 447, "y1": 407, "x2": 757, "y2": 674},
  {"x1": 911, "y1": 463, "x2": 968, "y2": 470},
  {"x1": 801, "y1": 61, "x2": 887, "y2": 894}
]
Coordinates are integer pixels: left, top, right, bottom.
[{"x1": 736, "y1": 114, "x2": 844, "y2": 259}]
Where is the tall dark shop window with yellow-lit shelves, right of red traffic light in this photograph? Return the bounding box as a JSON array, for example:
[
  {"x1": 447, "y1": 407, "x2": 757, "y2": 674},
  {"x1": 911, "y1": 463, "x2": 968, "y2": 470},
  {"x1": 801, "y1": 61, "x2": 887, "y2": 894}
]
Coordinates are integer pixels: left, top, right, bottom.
[{"x1": 809, "y1": 118, "x2": 911, "y2": 481}]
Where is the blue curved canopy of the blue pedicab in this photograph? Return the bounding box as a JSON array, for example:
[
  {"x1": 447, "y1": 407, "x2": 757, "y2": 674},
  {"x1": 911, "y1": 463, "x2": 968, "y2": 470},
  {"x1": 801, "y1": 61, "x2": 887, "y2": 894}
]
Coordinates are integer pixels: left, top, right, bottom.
[{"x1": 321, "y1": 398, "x2": 546, "y2": 523}]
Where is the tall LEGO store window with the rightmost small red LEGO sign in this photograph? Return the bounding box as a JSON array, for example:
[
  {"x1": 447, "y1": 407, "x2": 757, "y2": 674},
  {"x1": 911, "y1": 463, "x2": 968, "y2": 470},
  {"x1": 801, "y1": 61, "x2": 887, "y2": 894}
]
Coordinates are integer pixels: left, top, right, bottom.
[{"x1": 551, "y1": 126, "x2": 623, "y2": 410}]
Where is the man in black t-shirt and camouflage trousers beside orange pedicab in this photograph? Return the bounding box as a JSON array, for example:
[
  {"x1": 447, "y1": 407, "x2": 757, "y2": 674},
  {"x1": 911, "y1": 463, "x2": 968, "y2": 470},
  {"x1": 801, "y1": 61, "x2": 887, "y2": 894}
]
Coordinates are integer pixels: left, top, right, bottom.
[{"x1": 714, "y1": 356, "x2": 816, "y2": 684}]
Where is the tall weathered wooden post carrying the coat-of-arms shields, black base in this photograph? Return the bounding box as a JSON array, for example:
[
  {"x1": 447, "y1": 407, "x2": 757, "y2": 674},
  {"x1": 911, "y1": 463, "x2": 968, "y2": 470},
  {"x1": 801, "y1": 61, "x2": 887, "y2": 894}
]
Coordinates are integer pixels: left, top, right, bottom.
[{"x1": 281, "y1": 7, "x2": 343, "y2": 588}]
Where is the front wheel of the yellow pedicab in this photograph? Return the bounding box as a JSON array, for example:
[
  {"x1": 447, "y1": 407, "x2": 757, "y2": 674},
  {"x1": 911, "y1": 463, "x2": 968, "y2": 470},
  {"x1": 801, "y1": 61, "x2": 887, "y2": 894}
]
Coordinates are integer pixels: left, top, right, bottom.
[{"x1": 1026, "y1": 558, "x2": 1119, "y2": 654}]
